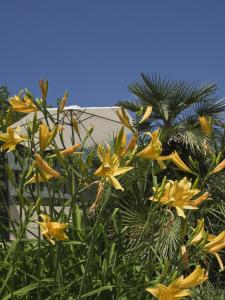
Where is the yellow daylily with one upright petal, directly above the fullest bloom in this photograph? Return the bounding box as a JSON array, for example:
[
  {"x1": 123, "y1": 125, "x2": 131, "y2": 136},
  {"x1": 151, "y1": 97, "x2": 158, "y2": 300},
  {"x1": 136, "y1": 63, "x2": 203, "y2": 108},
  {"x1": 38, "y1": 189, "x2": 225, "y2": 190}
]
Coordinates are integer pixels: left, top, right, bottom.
[{"x1": 137, "y1": 129, "x2": 170, "y2": 168}]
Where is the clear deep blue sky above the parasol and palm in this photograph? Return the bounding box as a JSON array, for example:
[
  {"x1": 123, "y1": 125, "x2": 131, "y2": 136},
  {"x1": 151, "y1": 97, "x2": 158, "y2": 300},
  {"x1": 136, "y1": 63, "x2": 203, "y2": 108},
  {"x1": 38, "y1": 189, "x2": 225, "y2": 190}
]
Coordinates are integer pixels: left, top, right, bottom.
[{"x1": 0, "y1": 0, "x2": 225, "y2": 106}]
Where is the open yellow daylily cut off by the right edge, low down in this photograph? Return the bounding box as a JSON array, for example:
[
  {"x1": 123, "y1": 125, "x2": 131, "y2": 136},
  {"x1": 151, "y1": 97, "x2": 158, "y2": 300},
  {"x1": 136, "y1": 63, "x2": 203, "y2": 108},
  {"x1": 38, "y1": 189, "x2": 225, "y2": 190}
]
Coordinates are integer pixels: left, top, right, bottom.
[{"x1": 204, "y1": 230, "x2": 225, "y2": 271}]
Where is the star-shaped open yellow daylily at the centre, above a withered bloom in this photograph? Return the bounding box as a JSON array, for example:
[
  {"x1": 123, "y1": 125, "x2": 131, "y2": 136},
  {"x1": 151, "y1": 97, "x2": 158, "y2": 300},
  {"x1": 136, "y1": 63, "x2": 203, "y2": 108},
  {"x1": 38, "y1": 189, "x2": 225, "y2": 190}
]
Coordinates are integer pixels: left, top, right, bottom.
[{"x1": 95, "y1": 145, "x2": 133, "y2": 191}]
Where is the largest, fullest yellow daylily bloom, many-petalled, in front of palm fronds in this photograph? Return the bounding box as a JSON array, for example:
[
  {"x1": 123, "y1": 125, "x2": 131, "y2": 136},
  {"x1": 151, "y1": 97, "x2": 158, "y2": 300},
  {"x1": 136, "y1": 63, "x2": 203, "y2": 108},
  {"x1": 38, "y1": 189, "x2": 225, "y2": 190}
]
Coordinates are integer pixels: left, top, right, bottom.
[{"x1": 149, "y1": 177, "x2": 209, "y2": 218}]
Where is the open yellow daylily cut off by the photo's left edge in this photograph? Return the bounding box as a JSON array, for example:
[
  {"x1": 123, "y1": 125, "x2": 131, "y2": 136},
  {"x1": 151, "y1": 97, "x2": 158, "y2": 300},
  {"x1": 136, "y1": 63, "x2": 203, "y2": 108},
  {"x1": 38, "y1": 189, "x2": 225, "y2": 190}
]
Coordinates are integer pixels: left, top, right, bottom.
[{"x1": 0, "y1": 127, "x2": 27, "y2": 151}]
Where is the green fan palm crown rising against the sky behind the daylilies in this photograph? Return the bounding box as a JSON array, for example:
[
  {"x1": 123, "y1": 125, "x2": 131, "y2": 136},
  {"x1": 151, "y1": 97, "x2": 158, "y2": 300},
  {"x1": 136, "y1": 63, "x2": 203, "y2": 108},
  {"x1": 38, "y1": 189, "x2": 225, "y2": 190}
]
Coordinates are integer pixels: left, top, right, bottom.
[{"x1": 117, "y1": 73, "x2": 225, "y2": 153}]
